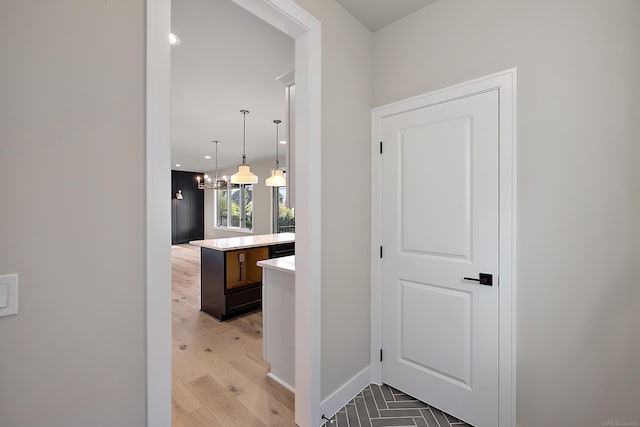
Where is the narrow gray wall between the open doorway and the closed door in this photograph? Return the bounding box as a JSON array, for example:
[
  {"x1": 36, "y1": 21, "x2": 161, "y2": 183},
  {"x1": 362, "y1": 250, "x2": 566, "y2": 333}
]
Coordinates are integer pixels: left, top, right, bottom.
[{"x1": 296, "y1": 0, "x2": 373, "y2": 403}]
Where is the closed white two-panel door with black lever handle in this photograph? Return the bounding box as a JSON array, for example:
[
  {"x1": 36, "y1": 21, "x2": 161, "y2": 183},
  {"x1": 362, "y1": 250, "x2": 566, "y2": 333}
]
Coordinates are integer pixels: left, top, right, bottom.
[{"x1": 382, "y1": 90, "x2": 498, "y2": 427}]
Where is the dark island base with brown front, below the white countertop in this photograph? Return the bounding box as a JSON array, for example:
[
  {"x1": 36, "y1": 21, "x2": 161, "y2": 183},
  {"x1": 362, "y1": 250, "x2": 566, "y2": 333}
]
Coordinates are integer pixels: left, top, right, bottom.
[{"x1": 200, "y1": 243, "x2": 295, "y2": 320}]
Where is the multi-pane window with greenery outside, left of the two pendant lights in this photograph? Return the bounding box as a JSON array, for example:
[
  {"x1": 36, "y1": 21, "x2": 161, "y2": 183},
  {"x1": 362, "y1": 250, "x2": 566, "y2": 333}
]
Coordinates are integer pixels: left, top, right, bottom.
[{"x1": 216, "y1": 181, "x2": 253, "y2": 231}]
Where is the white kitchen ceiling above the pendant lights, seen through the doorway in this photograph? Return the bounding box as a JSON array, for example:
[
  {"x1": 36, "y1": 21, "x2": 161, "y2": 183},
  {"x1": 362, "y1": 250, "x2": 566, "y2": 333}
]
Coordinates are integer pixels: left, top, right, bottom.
[{"x1": 171, "y1": 0, "x2": 294, "y2": 172}]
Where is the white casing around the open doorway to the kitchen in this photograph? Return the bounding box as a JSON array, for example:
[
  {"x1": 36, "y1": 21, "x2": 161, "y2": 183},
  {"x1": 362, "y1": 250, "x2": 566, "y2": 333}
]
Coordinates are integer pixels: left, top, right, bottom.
[{"x1": 145, "y1": 0, "x2": 321, "y2": 427}]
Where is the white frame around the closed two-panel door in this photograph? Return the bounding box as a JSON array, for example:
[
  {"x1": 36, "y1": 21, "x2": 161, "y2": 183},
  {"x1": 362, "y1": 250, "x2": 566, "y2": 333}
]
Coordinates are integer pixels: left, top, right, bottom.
[{"x1": 371, "y1": 68, "x2": 517, "y2": 427}]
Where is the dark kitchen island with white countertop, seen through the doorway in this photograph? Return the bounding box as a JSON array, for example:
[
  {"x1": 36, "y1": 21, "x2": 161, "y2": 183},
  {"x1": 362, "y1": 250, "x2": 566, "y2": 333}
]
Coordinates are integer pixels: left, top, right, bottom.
[{"x1": 189, "y1": 233, "x2": 295, "y2": 320}]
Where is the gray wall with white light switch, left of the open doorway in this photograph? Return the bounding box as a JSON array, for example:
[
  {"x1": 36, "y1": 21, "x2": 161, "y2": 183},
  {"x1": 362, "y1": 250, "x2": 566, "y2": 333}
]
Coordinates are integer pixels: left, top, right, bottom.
[{"x1": 0, "y1": 0, "x2": 146, "y2": 427}]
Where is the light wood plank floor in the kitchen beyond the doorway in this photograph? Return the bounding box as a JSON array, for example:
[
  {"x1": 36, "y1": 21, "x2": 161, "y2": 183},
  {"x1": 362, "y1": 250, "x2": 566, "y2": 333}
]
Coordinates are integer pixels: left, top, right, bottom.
[{"x1": 171, "y1": 245, "x2": 295, "y2": 427}]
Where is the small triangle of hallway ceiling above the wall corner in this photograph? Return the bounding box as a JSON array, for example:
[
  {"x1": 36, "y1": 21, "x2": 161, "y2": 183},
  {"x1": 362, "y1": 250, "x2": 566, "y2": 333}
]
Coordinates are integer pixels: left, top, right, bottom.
[{"x1": 337, "y1": 0, "x2": 436, "y2": 32}]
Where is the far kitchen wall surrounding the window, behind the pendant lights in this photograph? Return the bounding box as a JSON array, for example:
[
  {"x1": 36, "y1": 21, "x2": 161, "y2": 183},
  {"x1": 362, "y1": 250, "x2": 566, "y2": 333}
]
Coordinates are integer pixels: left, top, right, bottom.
[{"x1": 204, "y1": 155, "x2": 275, "y2": 239}]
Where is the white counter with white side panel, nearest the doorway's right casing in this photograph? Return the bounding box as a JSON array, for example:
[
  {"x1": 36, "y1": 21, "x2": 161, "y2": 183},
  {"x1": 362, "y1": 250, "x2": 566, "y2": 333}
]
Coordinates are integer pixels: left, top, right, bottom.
[{"x1": 258, "y1": 256, "x2": 296, "y2": 392}]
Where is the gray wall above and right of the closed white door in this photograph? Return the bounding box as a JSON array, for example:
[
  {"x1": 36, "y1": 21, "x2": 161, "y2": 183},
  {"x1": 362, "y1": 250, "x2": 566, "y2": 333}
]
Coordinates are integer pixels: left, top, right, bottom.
[{"x1": 373, "y1": 0, "x2": 640, "y2": 427}]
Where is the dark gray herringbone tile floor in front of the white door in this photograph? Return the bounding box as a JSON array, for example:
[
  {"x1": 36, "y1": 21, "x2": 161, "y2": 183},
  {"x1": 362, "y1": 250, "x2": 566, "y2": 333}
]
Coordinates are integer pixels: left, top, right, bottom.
[{"x1": 325, "y1": 384, "x2": 470, "y2": 427}]
